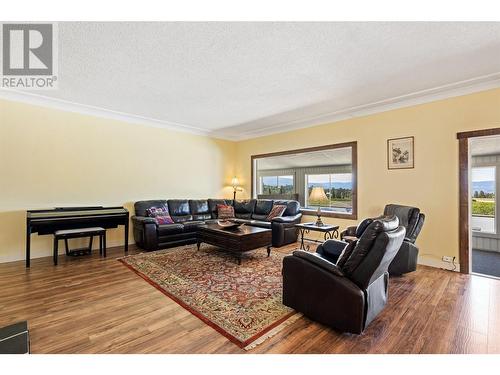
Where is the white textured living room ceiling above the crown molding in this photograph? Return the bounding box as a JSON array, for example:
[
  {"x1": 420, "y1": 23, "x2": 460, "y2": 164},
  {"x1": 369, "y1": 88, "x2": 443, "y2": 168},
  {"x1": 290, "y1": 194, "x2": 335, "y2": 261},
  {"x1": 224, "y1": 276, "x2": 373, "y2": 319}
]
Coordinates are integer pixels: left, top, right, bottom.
[{"x1": 5, "y1": 22, "x2": 500, "y2": 139}]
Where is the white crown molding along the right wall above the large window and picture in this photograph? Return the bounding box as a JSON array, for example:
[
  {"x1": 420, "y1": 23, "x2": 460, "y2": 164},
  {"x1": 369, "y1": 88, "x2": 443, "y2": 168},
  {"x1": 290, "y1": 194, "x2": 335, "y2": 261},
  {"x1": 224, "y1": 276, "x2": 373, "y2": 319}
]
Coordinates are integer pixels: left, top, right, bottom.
[{"x1": 220, "y1": 72, "x2": 500, "y2": 141}]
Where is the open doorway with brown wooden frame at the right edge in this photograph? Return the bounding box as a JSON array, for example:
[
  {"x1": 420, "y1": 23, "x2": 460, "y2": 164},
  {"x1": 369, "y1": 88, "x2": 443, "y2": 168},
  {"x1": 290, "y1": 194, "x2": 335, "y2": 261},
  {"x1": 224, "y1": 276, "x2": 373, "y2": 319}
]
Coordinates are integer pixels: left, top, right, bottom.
[{"x1": 457, "y1": 129, "x2": 500, "y2": 278}]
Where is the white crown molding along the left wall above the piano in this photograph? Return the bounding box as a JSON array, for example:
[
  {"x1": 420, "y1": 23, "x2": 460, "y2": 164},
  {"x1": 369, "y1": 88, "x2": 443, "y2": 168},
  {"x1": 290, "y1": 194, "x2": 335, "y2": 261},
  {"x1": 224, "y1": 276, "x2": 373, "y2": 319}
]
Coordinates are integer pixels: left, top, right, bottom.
[{"x1": 0, "y1": 88, "x2": 236, "y2": 139}]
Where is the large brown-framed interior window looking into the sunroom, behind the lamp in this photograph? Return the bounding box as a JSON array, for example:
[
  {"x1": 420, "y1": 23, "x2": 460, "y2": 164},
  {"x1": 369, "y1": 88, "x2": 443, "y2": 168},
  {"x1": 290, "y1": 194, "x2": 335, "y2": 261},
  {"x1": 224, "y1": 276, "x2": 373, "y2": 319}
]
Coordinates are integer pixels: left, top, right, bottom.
[{"x1": 251, "y1": 142, "x2": 357, "y2": 219}]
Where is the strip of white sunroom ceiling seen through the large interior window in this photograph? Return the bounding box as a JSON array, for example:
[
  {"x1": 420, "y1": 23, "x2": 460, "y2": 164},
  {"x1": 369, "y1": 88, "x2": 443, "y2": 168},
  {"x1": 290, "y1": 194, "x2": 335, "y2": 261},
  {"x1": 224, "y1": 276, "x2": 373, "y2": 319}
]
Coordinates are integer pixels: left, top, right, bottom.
[{"x1": 257, "y1": 147, "x2": 352, "y2": 170}]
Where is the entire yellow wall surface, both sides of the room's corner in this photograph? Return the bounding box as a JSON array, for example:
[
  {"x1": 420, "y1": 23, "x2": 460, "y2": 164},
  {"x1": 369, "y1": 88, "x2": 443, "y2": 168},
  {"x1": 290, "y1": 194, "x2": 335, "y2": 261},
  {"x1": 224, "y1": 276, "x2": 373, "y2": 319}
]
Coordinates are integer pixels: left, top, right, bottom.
[{"x1": 0, "y1": 89, "x2": 500, "y2": 263}]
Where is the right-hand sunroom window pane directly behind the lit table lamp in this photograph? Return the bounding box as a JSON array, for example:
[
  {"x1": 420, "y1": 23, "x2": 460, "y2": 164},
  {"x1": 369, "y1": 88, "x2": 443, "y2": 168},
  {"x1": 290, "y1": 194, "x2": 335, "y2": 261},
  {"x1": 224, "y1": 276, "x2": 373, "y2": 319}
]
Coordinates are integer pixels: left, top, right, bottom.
[{"x1": 305, "y1": 173, "x2": 352, "y2": 213}]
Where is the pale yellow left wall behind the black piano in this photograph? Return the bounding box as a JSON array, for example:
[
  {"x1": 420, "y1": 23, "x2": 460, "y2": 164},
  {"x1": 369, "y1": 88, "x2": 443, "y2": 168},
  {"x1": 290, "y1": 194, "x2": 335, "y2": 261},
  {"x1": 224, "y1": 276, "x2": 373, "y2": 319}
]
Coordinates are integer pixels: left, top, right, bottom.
[{"x1": 0, "y1": 100, "x2": 235, "y2": 262}]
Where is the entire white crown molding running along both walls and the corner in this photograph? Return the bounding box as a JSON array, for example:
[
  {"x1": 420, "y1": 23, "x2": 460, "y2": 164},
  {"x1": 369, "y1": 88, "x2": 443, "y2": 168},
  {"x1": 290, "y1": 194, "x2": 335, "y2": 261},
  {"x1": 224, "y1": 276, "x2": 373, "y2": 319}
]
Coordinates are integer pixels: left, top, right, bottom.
[{"x1": 0, "y1": 72, "x2": 500, "y2": 141}]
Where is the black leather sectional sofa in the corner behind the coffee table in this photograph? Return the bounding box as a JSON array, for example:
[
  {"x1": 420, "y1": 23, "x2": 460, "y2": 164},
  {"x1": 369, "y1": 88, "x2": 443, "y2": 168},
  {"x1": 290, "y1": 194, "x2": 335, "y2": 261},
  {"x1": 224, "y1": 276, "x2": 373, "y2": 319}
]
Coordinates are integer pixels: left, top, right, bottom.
[{"x1": 132, "y1": 199, "x2": 302, "y2": 250}]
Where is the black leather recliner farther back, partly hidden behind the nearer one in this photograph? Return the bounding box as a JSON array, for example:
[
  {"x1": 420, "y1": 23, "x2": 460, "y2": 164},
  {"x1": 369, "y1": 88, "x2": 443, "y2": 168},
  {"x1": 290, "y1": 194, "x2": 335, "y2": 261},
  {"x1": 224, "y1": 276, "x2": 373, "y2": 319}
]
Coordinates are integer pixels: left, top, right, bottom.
[{"x1": 340, "y1": 204, "x2": 425, "y2": 276}]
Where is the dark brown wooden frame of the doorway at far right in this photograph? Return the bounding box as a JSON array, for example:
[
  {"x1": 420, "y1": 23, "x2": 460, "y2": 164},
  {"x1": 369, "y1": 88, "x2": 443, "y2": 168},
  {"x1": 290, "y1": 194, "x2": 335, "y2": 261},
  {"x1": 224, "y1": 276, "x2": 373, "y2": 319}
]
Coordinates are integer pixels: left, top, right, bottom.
[{"x1": 457, "y1": 128, "x2": 500, "y2": 274}]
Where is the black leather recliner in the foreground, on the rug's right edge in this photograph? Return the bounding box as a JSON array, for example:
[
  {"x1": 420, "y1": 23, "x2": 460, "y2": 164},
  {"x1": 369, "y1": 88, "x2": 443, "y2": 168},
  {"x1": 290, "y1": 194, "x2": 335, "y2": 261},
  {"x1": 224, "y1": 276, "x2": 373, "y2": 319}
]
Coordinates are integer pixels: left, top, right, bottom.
[{"x1": 283, "y1": 216, "x2": 405, "y2": 334}]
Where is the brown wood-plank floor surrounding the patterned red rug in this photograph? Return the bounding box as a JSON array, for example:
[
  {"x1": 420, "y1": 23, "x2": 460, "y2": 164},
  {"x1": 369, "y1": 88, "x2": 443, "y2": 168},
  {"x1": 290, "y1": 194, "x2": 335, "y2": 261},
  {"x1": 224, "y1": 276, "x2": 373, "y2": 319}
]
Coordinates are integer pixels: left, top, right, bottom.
[{"x1": 0, "y1": 245, "x2": 500, "y2": 353}]
